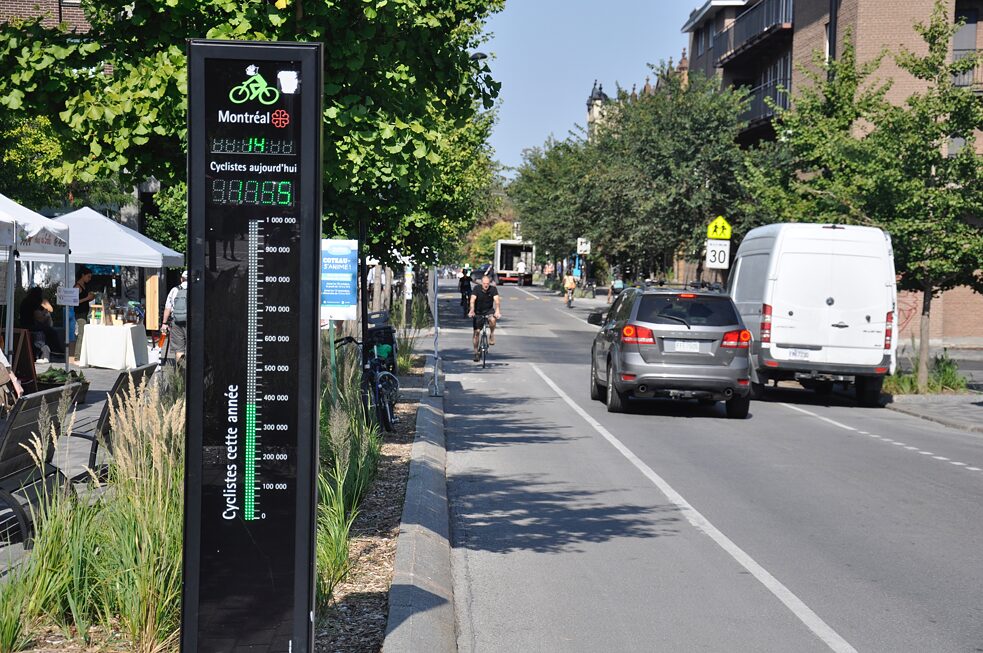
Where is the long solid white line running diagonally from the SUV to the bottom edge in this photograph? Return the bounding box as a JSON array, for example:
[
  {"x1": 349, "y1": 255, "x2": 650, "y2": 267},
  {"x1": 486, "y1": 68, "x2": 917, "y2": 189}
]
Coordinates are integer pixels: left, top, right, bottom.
[{"x1": 530, "y1": 363, "x2": 856, "y2": 653}]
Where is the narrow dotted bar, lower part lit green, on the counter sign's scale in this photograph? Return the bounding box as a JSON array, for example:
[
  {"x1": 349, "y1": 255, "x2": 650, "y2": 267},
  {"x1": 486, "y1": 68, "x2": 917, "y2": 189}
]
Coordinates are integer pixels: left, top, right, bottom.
[{"x1": 242, "y1": 220, "x2": 260, "y2": 521}]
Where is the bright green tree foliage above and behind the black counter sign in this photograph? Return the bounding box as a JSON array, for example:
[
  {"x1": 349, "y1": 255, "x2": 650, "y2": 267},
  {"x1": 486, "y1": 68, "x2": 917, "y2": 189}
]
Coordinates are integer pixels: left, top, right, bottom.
[{"x1": 0, "y1": 0, "x2": 504, "y2": 260}]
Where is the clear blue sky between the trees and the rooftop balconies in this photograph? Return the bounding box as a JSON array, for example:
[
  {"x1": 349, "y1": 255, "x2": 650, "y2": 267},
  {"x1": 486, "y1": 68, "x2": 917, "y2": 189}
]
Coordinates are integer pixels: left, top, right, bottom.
[{"x1": 481, "y1": 0, "x2": 703, "y2": 176}]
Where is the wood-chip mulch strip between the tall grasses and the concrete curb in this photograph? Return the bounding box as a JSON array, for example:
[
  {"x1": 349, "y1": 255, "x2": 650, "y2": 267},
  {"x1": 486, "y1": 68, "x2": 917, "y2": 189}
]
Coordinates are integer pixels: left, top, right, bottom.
[{"x1": 315, "y1": 358, "x2": 423, "y2": 653}]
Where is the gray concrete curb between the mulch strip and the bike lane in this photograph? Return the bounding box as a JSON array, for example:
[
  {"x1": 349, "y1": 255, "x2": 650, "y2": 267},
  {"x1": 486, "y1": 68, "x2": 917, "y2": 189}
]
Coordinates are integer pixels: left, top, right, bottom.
[{"x1": 382, "y1": 356, "x2": 457, "y2": 653}]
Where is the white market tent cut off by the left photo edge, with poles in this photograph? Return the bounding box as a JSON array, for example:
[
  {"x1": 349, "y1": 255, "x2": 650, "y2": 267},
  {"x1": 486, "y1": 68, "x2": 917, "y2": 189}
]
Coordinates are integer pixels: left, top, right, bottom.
[{"x1": 0, "y1": 194, "x2": 69, "y2": 368}]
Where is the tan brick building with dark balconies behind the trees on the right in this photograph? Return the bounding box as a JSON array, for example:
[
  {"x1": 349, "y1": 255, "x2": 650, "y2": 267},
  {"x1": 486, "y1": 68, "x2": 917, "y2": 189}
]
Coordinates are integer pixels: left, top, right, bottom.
[{"x1": 683, "y1": 0, "x2": 983, "y2": 347}]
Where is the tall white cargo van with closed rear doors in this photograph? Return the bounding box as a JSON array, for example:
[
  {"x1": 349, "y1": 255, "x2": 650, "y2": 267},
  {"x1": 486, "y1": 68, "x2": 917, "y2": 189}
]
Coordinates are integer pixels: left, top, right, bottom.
[{"x1": 728, "y1": 224, "x2": 898, "y2": 406}]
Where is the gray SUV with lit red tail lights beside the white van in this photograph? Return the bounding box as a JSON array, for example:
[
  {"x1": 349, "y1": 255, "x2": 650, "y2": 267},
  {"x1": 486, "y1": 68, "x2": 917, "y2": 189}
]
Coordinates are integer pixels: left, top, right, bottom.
[{"x1": 587, "y1": 288, "x2": 751, "y2": 419}]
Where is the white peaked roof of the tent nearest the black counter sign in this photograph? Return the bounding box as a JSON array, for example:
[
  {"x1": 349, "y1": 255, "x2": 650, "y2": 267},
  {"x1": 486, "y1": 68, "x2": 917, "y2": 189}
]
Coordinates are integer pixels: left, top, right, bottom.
[{"x1": 21, "y1": 207, "x2": 184, "y2": 268}]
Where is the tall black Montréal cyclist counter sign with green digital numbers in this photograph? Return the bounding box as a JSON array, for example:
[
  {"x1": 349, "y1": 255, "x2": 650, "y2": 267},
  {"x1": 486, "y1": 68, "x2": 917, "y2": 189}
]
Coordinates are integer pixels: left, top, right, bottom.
[{"x1": 181, "y1": 41, "x2": 323, "y2": 653}]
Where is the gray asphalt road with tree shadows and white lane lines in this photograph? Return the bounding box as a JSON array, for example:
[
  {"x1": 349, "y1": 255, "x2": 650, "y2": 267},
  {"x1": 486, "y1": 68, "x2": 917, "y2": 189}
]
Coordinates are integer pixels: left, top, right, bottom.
[{"x1": 441, "y1": 280, "x2": 983, "y2": 653}]
